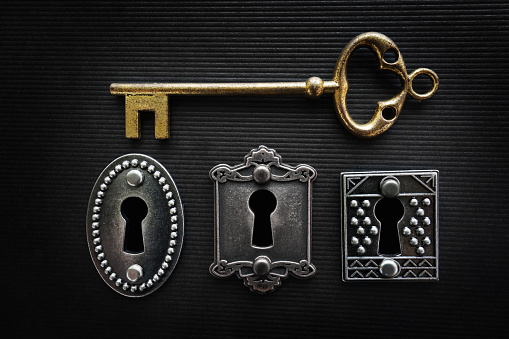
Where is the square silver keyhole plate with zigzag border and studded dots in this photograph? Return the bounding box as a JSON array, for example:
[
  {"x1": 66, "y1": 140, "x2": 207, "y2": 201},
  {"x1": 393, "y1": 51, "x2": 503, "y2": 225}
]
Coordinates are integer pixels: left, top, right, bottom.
[{"x1": 341, "y1": 170, "x2": 438, "y2": 281}]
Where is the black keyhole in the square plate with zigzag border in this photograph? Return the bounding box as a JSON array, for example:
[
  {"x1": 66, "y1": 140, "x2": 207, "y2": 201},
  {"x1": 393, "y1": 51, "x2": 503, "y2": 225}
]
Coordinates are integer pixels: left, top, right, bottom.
[{"x1": 375, "y1": 198, "x2": 405, "y2": 255}]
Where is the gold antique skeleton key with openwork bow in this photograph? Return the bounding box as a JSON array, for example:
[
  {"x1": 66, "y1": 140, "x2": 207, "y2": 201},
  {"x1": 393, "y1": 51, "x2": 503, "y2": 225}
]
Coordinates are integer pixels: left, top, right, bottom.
[{"x1": 110, "y1": 32, "x2": 438, "y2": 139}]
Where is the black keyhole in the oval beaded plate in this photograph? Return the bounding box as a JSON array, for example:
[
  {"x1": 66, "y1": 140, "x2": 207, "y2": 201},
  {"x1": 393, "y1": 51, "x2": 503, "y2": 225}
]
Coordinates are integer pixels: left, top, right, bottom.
[{"x1": 120, "y1": 197, "x2": 148, "y2": 254}]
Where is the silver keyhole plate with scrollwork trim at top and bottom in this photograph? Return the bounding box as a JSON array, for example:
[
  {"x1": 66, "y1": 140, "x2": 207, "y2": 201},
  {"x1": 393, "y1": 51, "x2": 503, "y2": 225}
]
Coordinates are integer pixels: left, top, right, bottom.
[{"x1": 210, "y1": 146, "x2": 316, "y2": 293}]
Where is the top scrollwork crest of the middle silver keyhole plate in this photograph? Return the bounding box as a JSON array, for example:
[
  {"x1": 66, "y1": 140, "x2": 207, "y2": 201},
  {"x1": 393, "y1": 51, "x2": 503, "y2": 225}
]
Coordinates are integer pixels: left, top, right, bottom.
[{"x1": 210, "y1": 146, "x2": 316, "y2": 183}]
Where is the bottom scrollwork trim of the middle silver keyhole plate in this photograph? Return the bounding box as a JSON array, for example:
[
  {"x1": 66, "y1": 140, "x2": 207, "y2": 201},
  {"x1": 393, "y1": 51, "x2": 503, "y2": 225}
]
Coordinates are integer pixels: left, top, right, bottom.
[{"x1": 210, "y1": 260, "x2": 316, "y2": 293}]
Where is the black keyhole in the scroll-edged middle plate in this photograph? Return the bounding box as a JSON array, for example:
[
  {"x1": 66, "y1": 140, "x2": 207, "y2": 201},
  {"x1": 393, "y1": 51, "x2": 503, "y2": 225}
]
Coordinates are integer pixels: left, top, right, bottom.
[{"x1": 249, "y1": 190, "x2": 277, "y2": 247}]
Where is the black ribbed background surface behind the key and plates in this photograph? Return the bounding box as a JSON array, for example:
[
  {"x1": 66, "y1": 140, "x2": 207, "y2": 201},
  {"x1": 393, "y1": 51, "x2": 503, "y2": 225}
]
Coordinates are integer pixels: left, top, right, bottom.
[{"x1": 0, "y1": 1, "x2": 509, "y2": 338}]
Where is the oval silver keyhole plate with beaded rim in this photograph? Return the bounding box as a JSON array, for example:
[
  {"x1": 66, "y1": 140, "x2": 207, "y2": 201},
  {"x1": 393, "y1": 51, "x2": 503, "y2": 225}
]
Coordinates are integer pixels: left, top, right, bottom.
[{"x1": 87, "y1": 154, "x2": 184, "y2": 297}]
